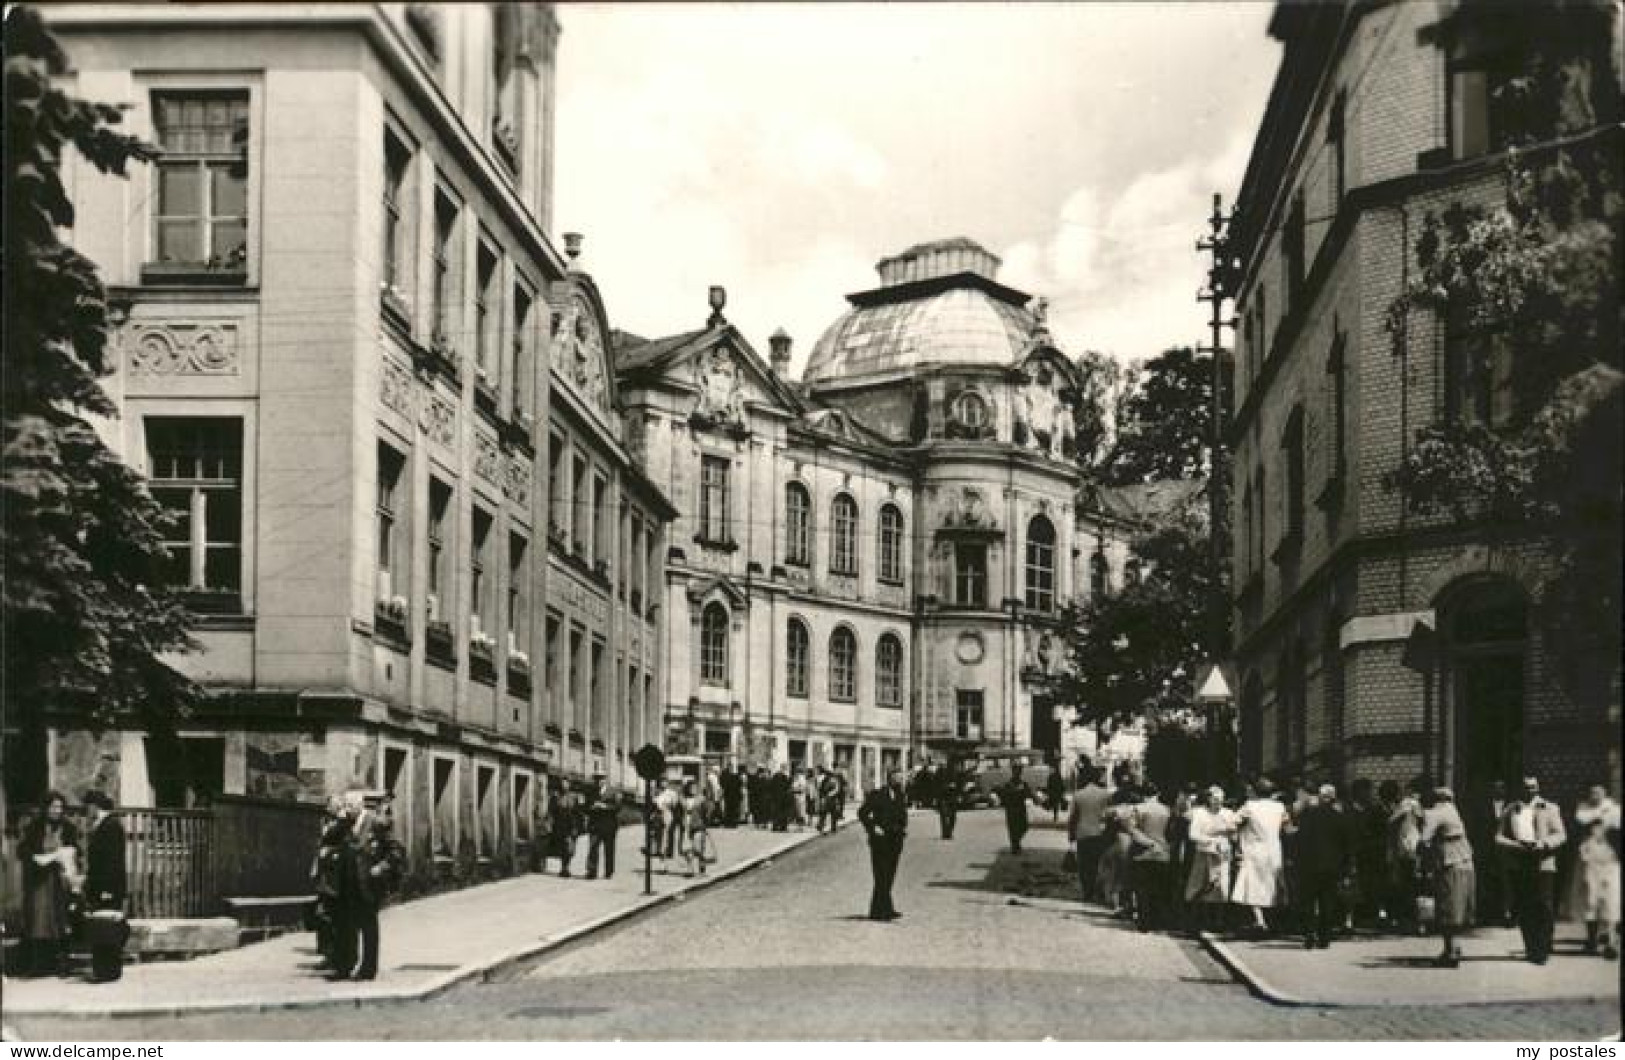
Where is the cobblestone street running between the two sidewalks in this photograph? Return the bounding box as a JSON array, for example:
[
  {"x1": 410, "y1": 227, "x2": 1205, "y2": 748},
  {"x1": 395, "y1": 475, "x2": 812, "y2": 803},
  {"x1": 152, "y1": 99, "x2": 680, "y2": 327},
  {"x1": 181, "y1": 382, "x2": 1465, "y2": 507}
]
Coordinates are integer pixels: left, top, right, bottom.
[{"x1": 18, "y1": 813, "x2": 1619, "y2": 1040}]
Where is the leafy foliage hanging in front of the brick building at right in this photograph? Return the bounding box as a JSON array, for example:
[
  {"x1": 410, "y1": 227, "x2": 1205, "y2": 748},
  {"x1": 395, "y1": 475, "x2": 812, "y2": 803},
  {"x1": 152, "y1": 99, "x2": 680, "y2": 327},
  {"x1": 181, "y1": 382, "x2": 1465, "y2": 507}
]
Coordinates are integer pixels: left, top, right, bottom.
[{"x1": 1386, "y1": 151, "x2": 1625, "y2": 650}]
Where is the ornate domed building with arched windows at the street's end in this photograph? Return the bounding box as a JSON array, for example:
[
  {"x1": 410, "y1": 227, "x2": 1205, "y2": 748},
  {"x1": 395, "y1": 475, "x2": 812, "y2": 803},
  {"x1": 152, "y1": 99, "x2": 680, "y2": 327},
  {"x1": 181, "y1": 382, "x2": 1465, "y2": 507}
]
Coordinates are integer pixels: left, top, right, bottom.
[{"x1": 618, "y1": 239, "x2": 1123, "y2": 785}]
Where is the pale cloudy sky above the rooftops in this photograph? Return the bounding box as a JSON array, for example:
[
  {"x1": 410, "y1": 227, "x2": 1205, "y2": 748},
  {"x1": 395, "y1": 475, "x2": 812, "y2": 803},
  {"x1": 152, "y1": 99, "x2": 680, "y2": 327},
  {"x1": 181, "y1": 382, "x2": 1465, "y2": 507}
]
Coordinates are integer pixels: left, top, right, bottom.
[{"x1": 554, "y1": 0, "x2": 1279, "y2": 372}]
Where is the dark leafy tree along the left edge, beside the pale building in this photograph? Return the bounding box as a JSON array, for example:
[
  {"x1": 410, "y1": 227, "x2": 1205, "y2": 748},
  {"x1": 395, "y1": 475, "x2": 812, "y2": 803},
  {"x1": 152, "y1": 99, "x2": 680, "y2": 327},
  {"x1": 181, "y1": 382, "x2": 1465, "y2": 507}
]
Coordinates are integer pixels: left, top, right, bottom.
[{"x1": 0, "y1": 8, "x2": 197, "y2": 760}]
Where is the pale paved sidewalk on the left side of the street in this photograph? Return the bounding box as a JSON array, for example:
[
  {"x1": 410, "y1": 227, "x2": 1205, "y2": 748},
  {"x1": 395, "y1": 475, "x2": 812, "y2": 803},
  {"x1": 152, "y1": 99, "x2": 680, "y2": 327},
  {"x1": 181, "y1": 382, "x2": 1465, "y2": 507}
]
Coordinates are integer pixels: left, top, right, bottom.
[{"x1": 0, "y1": 818, "x2": 850, "y2": 1019}]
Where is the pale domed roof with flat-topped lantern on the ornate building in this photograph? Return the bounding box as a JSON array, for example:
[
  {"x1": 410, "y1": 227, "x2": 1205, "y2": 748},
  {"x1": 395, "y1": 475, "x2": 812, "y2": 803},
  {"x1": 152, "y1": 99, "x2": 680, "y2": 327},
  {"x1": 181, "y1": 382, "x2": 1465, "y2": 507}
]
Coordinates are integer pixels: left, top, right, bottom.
[{"x1": 803, "y1": 237, "x2": 1042, "y2": 384}]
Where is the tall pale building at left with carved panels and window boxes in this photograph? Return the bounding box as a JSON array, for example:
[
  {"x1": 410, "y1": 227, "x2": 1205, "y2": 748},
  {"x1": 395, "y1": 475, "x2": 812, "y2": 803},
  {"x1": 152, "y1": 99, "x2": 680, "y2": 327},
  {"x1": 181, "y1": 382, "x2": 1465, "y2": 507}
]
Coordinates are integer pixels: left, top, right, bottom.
[{"x1": 19, "y1": 3, "x2": 673, "y2": 880}]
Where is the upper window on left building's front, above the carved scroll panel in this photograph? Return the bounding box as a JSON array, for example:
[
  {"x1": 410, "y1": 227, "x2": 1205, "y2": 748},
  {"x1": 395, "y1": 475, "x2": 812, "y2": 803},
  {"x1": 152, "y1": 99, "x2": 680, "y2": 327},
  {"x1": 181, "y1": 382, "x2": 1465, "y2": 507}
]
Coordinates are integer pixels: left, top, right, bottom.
[{"x1": 153, "y1": 91, "x2": 249, "y2": 272}]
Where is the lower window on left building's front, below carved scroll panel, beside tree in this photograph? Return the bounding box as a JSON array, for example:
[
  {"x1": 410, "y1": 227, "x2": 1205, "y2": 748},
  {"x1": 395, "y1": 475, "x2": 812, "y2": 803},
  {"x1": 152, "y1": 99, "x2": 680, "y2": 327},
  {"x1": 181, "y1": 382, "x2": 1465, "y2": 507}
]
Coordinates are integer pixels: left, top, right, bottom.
[{"x1": 146, "y1": 416, "x2": 242, "y2": 595}]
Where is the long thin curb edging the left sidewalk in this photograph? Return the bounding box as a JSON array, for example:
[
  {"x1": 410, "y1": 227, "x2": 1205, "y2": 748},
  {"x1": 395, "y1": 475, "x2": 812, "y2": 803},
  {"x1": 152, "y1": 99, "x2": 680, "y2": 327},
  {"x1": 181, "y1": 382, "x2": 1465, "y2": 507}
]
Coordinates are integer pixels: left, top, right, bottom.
[{"x1": 5, "y1": 818, "x2": 856, "y2": 1020}]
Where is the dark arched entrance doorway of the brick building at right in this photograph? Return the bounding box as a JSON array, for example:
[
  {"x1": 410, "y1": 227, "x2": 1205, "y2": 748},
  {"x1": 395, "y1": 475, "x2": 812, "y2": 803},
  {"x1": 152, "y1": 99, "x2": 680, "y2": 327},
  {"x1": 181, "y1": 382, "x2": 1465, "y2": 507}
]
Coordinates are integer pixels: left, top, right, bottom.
[{"x1": 1440, "y1": 579, "x2": 1529, "y2": 798}]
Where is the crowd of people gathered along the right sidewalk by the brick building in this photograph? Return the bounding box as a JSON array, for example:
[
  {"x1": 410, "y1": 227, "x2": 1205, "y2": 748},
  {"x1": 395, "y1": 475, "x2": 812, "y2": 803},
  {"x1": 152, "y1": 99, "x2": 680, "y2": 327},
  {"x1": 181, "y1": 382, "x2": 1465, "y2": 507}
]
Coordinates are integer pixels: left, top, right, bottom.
[{"x1": 1046, "y1": 764, "x2": 1620, "y2": 967}]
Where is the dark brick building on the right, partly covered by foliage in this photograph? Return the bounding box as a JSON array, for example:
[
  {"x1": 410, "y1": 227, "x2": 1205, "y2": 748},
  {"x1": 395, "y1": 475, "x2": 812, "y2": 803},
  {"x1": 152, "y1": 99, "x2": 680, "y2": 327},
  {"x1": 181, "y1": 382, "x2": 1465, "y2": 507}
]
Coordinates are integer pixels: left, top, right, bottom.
[{"x1": 1229, "y1": 2, "x2": 1620, "y2": 798}]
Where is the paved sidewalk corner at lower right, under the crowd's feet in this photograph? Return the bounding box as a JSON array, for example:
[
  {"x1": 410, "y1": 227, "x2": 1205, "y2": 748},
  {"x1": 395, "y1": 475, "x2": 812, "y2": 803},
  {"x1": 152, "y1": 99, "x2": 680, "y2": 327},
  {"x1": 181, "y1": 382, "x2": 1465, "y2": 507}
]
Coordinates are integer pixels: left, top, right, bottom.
[{"x1": 1203, "y1": 923, "x2": 1620, "y2": 1008}]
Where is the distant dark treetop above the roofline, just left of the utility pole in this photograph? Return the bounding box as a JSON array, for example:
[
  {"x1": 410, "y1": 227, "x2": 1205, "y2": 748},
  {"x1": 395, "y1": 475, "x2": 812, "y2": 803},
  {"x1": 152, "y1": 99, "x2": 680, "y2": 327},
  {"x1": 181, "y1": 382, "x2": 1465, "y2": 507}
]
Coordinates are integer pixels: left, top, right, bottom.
[{"x1": 1092, "y1": 346, "x2": 1214, "y2": 486}]
